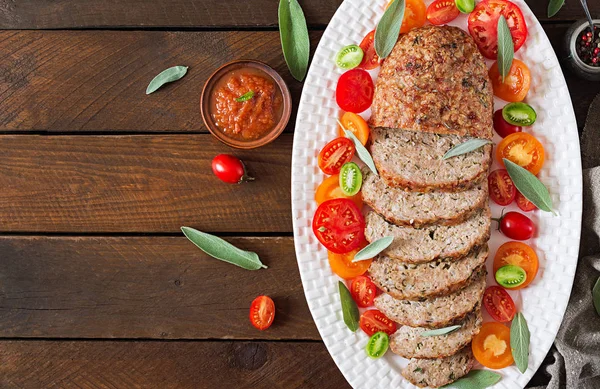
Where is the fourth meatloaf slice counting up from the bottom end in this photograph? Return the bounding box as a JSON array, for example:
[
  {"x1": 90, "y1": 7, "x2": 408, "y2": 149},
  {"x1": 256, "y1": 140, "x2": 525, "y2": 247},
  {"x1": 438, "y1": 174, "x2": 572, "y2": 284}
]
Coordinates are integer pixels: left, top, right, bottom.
[{"x1": 369, "y1": 245, "x2": 489, "y2": 300}]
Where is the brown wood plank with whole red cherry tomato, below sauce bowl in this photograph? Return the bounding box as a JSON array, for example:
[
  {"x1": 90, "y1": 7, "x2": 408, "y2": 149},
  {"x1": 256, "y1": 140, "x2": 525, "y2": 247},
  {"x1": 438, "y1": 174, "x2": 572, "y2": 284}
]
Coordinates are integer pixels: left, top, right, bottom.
[{"x1": 0, "y1": 134, "x2": 292, "y2": 233}]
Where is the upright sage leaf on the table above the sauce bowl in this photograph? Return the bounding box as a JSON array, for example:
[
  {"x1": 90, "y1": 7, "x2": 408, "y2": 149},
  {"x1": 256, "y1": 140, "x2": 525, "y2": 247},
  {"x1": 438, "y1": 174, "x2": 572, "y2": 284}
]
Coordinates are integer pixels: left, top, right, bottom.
[{"x1": 278, "y1": 0, "x2": 310, "y2": 81}]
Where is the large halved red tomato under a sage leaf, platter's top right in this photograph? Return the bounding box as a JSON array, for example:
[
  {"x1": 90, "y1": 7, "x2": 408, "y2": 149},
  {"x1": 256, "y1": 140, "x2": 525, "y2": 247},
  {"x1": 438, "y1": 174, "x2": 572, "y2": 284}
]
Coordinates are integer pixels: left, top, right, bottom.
[{"x1": 468, "y1": 0, "x2": 527, "y2": 59}]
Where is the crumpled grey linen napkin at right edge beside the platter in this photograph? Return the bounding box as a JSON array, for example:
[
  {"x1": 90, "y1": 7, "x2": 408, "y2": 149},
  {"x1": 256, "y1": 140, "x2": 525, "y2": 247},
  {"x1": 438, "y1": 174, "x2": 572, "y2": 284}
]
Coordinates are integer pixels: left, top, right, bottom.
[{"x1": 535, "y1": 95, "x2": 600, "y2": 389}]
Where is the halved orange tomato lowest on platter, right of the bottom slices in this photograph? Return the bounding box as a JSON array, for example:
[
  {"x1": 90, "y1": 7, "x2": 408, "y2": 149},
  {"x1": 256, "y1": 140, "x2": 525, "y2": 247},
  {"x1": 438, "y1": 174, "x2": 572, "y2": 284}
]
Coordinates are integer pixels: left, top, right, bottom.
[{"x1": 472, "y1": 322, "x2": 514, "y2": 369}]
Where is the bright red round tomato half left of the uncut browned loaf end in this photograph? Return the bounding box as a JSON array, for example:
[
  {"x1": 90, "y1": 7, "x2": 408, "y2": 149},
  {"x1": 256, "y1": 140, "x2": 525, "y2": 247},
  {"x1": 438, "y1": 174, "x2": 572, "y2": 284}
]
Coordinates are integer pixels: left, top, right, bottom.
[{"x1": 335, "y1": 69, "x2": 375, "y2": 113}]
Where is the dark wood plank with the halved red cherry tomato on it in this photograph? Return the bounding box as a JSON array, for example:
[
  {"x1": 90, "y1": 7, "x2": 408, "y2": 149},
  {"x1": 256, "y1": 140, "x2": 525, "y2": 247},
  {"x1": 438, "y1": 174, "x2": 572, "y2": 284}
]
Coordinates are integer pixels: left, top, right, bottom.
[{"x1": 0, "y1": 236, "x2": 320, "y2": 338}]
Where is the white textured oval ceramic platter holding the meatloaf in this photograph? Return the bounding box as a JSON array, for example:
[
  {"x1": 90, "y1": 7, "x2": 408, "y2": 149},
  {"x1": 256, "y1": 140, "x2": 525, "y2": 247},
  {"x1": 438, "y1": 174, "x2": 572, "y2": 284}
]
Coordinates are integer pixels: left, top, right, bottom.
[{"x1": 292, "y1": 0, "x2": 582, "y2": 389}]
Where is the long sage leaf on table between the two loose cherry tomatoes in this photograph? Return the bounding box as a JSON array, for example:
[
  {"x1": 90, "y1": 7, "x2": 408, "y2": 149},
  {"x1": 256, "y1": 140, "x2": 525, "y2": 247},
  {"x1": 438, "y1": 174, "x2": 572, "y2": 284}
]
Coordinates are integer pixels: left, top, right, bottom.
[{"x1": 181, "y1": 227, "x2": 267, "y2": 270}]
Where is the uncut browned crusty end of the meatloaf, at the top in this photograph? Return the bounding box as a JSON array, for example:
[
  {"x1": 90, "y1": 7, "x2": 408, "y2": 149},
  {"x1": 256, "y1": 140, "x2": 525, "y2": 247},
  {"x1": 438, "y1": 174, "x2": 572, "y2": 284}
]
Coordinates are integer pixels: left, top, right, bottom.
[{"x1": 370, "y1": 26, "x2": 494, "y2": 139}]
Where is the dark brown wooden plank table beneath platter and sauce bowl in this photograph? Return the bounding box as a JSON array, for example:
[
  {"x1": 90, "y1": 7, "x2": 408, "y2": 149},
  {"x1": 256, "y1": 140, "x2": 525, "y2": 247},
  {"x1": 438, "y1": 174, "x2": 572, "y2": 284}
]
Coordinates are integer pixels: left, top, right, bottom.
[{"x1": 0, "y1": 0, "x2": 600, "y2": 389}]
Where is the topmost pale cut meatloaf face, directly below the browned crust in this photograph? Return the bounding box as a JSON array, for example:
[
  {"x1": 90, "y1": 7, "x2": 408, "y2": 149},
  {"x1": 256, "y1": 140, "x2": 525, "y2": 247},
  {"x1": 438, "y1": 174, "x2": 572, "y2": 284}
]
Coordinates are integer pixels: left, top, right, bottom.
[{"x1": 370, "y1": 128, "x2": 492, "y2": 192}]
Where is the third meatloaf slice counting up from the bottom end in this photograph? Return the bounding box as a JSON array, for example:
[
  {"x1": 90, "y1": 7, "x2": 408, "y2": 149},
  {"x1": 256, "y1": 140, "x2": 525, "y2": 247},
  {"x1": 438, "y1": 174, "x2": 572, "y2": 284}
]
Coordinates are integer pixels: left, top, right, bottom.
[{"x1": 375, "y1": 268, "x2": 486, "y2": 328}]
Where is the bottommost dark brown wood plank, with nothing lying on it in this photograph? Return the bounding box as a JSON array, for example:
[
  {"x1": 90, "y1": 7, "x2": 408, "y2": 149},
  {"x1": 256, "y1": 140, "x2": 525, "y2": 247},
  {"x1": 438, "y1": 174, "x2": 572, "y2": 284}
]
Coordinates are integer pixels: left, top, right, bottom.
[{"x1": 0, "y1": 341, "x2": 350, "y2": 389}]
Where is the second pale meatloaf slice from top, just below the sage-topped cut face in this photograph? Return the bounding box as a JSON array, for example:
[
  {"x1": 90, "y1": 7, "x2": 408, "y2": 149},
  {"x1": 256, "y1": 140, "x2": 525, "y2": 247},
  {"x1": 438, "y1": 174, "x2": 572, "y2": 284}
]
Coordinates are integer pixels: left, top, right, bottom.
[{"x1": 361, "y1": 169, "x2": 488, "y2": 227}]
